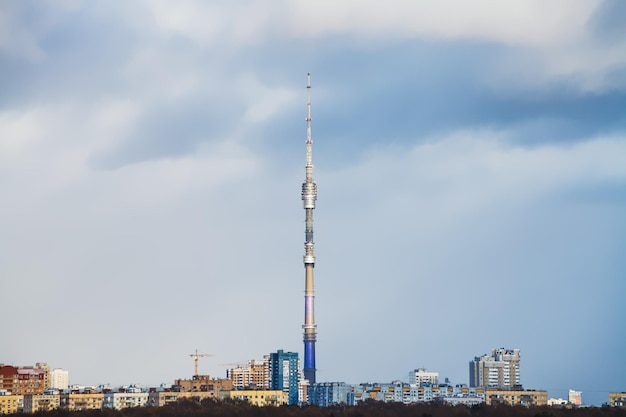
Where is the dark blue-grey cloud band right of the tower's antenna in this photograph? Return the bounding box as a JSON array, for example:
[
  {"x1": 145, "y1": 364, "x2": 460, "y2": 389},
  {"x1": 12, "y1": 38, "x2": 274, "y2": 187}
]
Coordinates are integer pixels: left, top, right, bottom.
[{"x1": 322, "y1": 44, "x2": 626, "y2": 144}]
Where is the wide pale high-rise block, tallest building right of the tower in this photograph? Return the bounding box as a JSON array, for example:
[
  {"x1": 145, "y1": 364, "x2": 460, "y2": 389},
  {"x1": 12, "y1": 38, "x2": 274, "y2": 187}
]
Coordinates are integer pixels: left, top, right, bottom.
[{"x1": 469, "y1": 348, "x2": 521, "y2": 389}]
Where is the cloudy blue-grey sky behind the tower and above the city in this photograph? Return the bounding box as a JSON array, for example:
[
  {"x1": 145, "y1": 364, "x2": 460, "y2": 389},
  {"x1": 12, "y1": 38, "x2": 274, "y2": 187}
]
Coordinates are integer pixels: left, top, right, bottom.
[{"x1": 0, "y1": 0, "x2": 626, "y2": 404}]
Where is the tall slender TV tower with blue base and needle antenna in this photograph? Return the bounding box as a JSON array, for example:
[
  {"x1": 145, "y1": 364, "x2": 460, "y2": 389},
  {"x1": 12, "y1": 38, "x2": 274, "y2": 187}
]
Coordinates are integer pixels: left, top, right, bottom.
[{"x1": 302, "y1": 73, "x2": 317, "y2": 384}]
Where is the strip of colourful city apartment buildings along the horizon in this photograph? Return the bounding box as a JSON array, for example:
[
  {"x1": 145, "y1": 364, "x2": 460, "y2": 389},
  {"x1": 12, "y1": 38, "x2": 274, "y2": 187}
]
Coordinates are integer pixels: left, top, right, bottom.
[{"x1": 0, "y1": 348, "x2": 604, "y2": 406}]
